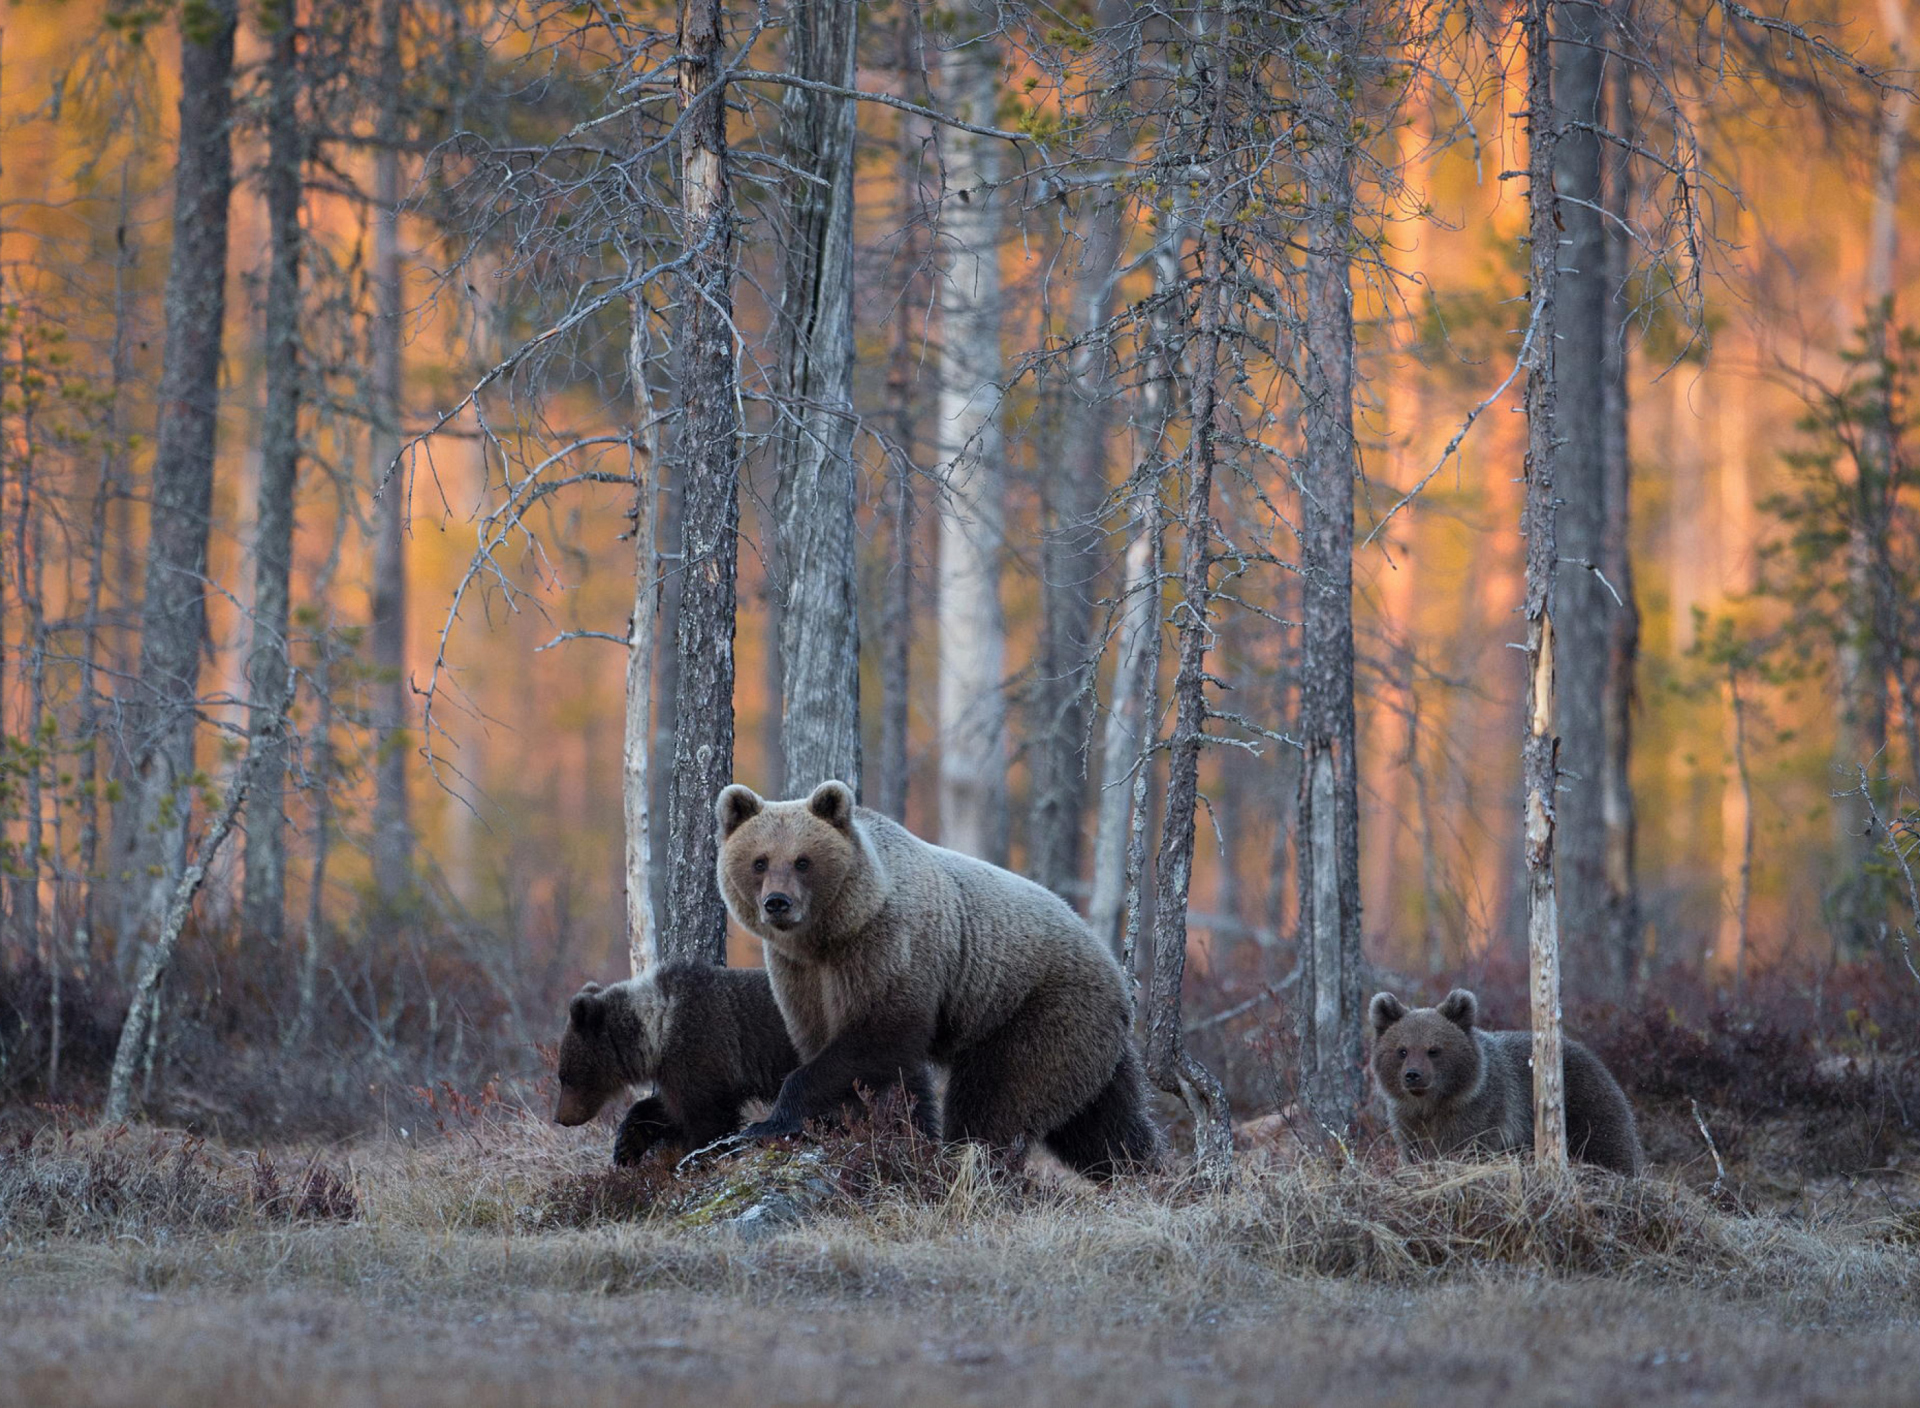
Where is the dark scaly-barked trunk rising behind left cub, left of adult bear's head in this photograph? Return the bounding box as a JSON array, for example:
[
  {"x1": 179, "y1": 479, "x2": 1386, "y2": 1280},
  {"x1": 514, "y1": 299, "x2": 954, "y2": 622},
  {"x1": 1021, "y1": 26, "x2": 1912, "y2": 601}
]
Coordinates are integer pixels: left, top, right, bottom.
[{"x1": 660, "y1": 0, "x2": 739, "y2": 962}]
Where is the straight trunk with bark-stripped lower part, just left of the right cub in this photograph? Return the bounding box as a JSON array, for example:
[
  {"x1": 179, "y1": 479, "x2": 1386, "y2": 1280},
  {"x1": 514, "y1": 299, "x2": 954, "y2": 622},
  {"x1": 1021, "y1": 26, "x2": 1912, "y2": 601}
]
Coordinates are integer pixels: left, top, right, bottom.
[{"x1": 1294, "y1": 12, "x2": 1361, "y2": 1135}]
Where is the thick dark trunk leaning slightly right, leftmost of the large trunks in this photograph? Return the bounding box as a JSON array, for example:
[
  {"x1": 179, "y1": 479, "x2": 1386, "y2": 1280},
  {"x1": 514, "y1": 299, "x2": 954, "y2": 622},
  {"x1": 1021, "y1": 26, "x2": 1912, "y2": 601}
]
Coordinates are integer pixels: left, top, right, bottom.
[{"x1": 117, "y1": 0, "x2": 238, "y2": 953}]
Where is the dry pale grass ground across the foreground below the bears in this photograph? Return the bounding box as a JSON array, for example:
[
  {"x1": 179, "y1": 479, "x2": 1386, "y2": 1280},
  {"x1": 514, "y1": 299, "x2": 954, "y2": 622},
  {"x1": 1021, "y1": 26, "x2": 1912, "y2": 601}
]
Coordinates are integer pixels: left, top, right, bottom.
[{"x1": 0, "y1": 1110, "x2": 1920, "y2": 1408}]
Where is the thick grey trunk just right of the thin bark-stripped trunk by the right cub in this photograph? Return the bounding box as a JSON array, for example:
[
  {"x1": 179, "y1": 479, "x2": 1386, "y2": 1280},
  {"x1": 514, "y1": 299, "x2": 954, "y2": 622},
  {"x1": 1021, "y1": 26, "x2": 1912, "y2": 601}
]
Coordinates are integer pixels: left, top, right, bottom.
[{"x1": 1553, "y1": 4, "x2": 1626, "y2": 995}]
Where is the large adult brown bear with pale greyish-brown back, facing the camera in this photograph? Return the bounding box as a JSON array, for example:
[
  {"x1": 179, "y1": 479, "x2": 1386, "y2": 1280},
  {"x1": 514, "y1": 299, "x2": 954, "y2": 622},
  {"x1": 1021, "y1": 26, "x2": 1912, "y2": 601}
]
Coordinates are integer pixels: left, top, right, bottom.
[{"x1": 716, "y1": 782, "x2": 1162, "y2": 1177}]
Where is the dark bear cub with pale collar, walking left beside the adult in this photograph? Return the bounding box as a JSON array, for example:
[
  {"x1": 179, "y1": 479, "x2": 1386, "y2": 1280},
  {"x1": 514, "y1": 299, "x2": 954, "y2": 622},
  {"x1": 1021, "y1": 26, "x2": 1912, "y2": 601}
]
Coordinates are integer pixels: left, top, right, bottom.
[{"x1": 553, "y1": 962, "x2": 801, "y2": 1164}]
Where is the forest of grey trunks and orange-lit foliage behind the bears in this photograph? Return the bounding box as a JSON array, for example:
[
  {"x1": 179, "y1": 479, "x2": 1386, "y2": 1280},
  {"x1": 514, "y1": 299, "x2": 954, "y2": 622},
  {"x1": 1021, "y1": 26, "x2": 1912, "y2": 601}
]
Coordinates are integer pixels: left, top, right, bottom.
[{"x1": 0, "y1": 0, "x2": 1920, "y2": 1126}]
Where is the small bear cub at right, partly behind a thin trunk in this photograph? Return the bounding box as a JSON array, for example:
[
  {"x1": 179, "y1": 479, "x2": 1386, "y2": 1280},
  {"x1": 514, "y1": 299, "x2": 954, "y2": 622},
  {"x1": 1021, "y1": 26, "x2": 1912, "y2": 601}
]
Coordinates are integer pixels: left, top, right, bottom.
[{"x1": 1367, "y1": 987, "x2": 1644, "y2": 1176}]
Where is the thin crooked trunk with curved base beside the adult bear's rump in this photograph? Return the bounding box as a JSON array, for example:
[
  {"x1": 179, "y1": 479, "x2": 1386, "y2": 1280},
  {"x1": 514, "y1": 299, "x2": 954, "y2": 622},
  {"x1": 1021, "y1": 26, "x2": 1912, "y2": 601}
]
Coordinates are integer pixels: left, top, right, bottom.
[{"x1": 1146, "y1": 232, "x2": 1233, "y2": 1183}]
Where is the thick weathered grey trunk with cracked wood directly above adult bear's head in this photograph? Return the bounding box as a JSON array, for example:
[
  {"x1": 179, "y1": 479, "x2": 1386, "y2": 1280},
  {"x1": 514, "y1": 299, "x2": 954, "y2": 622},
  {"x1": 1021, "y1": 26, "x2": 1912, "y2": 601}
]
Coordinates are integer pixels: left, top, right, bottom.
[{"x1": 774, "y1": 4, "x2": 860, "y2": 797}]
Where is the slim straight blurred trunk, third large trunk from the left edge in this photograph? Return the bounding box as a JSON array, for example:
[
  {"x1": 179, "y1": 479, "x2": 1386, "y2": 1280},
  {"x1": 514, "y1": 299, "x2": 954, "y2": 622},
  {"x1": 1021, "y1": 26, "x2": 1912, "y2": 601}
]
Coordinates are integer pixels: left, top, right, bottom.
[{"x1": 367, "y1": 0, "x2": 413, "y2": 910}]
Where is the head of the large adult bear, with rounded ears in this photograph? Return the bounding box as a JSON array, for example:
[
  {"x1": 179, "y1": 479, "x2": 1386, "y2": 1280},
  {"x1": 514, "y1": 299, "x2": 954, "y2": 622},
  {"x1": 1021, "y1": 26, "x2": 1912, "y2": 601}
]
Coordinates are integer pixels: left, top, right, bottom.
[{"x1": 716, "y1": 782, "x2": 864, "y2": 947}]
